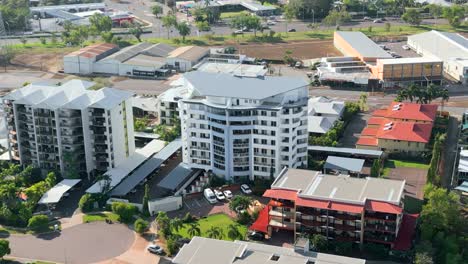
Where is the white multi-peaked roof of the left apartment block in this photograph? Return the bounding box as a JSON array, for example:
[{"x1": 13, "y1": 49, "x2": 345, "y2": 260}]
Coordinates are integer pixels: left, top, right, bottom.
[{"x1": 3, "y1": 80, "x2": 133, "y2": 109}]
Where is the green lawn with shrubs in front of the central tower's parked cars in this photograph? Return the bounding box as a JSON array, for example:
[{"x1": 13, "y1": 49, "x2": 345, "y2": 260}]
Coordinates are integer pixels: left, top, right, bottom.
[{"x1": 176, "y1": 214, "x2": 247, "y2": 241}]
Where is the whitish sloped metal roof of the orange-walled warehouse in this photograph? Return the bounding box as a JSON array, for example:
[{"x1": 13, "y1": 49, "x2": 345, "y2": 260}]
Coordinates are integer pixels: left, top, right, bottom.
[{"x1": 336, "y1": 31, "x2": 393, "y2": 58}]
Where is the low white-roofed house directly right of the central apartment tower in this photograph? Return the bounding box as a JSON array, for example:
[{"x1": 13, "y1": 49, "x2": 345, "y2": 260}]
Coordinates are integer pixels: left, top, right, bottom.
[{"x1": 307, "y1": 96, "x2": 345, "y2": 135}]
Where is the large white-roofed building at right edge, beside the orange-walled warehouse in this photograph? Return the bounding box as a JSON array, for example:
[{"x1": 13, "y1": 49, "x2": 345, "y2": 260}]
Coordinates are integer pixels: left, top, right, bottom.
[{"x1": 408, "y1": 30, "x2": 468, "y2": 84}]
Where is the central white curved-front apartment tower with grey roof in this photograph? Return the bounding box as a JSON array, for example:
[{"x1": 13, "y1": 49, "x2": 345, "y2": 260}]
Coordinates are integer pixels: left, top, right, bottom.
[{"x1": 178, "y1": 71, "x2": 308, "y2": 181}]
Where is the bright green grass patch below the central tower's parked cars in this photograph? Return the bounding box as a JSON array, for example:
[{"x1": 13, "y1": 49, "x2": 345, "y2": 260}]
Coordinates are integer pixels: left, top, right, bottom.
[{"x1": 177, "y1": 214, "x2": 247, "y2": 240}]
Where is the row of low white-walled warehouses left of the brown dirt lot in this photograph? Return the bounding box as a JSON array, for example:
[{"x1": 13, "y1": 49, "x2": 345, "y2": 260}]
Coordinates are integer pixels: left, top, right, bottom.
[{"x1": 63, "y1": 42, "x2": 209, "y2": 78}]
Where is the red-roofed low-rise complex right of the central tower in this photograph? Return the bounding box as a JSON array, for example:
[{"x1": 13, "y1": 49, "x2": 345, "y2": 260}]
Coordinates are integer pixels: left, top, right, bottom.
[{"x1": 356, "y1": 102, "x2": 437, "y2": 154}]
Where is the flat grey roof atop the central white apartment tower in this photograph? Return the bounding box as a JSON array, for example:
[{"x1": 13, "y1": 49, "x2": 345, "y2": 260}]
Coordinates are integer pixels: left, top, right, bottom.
[{"x1": 183, "y1": 71, "x2": 309, "y2": 100}]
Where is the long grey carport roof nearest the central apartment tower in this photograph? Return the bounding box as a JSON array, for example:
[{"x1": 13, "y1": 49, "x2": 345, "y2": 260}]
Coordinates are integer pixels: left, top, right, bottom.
[{"x1": 111, "y1": 139, "x2": 182, "y2": 196}]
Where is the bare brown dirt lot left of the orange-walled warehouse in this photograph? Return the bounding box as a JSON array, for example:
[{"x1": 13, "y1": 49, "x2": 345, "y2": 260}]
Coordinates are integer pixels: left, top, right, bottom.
[{"x1": 235, "y1": 40, "x2": 342, "y2": 60}]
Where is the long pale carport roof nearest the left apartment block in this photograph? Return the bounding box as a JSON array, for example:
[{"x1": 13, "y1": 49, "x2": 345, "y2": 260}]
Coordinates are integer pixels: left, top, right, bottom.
[{"x1": 86, "y1": 139, "x2": 166, "y2": 193}]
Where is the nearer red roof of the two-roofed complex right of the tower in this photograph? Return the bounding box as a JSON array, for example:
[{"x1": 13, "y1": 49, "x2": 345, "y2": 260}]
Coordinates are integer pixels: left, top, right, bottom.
[{"x1": 377, "y1": 121, "x2": 433, "y2": 143}]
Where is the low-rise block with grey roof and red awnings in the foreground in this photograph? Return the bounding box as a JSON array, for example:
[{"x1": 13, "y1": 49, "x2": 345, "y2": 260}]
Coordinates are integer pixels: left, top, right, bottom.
[{"x1": 251, "y1": 168, "x2": 416, "y2": 250}]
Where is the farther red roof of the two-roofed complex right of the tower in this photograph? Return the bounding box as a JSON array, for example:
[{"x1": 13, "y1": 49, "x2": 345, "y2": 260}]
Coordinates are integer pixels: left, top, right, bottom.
[{"x1": 382, "y1": 102, "x2": 438, "y2": 121}]
